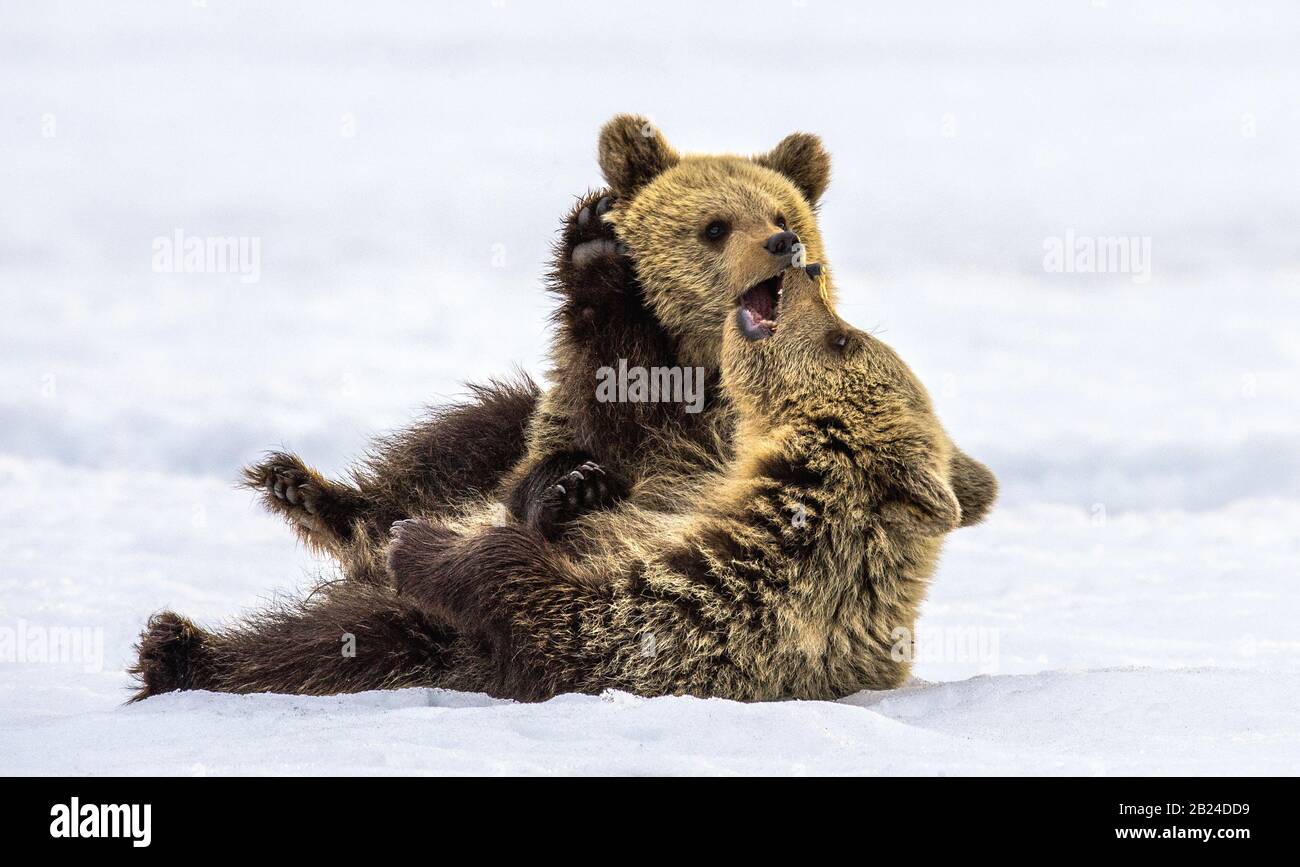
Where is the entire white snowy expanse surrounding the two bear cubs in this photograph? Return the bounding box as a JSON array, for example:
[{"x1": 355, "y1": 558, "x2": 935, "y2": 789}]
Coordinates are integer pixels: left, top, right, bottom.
[{"x1": 0, "y1": 0, "x2": 1300, "y2": 773}]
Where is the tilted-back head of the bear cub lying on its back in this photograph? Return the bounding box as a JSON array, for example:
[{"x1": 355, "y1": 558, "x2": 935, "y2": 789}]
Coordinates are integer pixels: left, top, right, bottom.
[{"x1": 722, "y1": 266, "x2": 997, "y2": 536}]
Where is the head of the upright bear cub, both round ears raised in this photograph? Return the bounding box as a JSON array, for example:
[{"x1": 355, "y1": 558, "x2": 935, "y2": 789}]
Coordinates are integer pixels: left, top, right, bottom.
[{"x1": 599, "y1": 114, "x2": 833, "y2": 367}]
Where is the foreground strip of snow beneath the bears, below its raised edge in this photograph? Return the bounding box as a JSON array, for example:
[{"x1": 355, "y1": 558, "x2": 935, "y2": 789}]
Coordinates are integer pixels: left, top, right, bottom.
[{"x1": 7, "y1": 669, "x2": 1300, "y2": 776}]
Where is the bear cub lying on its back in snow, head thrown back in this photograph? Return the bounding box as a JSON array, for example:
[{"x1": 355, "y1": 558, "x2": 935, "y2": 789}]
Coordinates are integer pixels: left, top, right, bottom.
[{"x1": 137, "y1": 269, "x2": 993, "y2": 701}]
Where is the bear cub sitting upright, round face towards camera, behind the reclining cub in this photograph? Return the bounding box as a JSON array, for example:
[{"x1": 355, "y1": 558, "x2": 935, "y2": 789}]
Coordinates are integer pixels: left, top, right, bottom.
[{"x1": 244, "y1": 114, "x2": 829, "y2": 569}]
